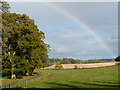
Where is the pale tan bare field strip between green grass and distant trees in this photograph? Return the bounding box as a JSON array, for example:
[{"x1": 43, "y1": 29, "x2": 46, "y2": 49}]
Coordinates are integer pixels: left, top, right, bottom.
[{"x1": 44, "y1": 62, "x2": 116, "y2": 69}]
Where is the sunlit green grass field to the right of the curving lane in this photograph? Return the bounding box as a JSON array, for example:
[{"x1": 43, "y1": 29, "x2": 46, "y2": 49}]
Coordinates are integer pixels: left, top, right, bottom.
[{"x1": 7, "y1": 66, "x2": 118, "y2": 88}]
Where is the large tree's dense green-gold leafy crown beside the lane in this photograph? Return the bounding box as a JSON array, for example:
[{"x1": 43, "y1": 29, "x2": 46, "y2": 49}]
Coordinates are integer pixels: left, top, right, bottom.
[{"x1": 2, "y1": 13, "x2": 50, "y2": 78}]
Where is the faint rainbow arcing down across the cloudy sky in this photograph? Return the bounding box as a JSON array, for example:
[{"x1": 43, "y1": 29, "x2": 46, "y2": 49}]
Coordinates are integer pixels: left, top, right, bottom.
[{"x1": 46, "y1": 2, "x2": 115, "y2": 57}]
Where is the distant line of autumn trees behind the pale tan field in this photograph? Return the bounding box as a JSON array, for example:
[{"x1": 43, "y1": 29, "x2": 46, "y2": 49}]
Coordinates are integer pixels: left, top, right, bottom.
[{"x1": 47, "y1": 58, "x2": 114, "y2": 66}]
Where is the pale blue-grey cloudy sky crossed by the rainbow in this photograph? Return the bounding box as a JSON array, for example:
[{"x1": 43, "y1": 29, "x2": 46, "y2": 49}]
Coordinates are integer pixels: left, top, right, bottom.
[{"x1": 9, "y1": 2, "x2": 118, "y2": 60}]
